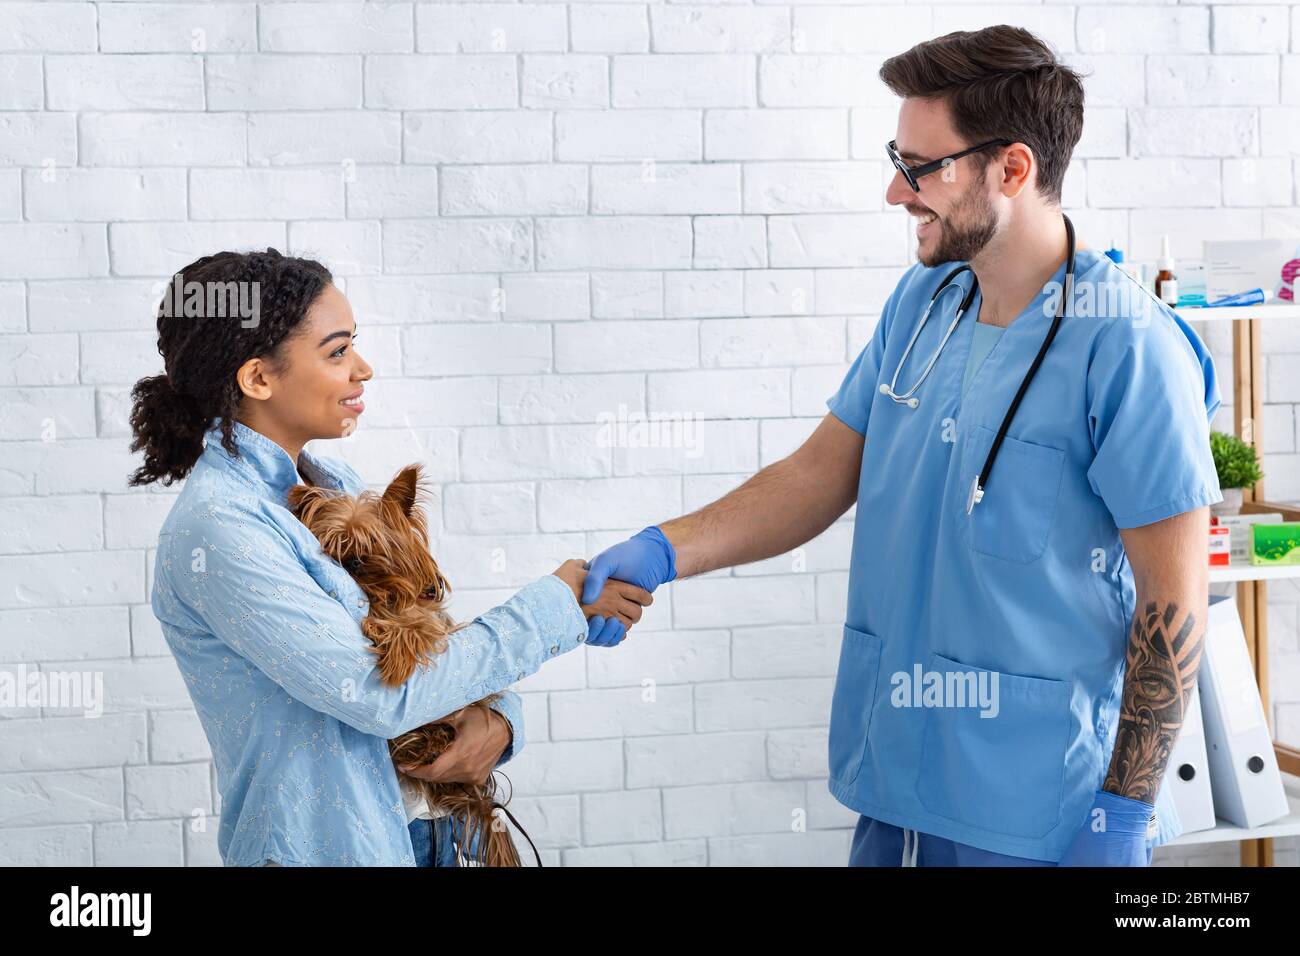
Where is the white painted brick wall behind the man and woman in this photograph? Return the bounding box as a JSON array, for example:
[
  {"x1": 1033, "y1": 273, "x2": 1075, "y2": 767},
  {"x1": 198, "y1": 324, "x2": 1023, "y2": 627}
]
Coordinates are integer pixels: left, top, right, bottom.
[{"x1": 0, "y1": 0, "x2": 1300, "y2": 865}]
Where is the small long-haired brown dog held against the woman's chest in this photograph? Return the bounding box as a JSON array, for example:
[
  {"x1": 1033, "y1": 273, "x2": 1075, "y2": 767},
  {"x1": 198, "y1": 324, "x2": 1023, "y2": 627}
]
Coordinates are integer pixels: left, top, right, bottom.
[{"x1": 289, "y1": 464, "x2": 521, "y2": 866}]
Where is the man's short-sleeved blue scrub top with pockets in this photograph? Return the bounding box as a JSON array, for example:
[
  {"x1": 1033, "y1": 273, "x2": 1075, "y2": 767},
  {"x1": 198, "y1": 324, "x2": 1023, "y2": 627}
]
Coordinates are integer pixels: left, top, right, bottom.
[{"x1": 827, "y1": 250, "x2": 1222, "y2": 861}]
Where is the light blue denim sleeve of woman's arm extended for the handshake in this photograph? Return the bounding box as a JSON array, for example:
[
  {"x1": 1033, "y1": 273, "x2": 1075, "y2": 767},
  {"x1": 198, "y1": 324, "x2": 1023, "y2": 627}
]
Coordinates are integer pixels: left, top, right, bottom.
[{"x1": 157, "y1": 501, "x2": 647, "y2": 737}]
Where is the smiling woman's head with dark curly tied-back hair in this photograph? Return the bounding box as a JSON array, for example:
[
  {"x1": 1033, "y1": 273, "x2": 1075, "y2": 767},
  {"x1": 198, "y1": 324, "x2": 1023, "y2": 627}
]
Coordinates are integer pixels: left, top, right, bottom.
[{"x1": 131, "y1": 248, "x2": 373, "y2": 485}]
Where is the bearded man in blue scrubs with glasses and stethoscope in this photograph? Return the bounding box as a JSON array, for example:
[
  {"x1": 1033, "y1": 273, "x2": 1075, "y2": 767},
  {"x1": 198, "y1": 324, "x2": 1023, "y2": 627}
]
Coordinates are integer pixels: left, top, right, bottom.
[{"x1": 586, "y1": 26, "x2": 1222, "y2": 866}]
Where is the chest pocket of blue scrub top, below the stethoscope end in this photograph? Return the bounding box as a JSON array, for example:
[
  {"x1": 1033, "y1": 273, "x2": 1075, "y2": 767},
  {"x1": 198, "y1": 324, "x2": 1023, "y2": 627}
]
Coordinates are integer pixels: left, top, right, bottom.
[{"x1": 957, "y1": 425, "x2": 1065, "y2": 564}]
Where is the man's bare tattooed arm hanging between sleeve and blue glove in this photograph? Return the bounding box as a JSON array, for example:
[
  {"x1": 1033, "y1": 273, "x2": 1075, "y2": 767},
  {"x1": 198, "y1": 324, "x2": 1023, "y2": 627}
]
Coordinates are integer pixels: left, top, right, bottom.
[{"x1": 1102, "y1": 507, "x2": 1209, "y2": 804}]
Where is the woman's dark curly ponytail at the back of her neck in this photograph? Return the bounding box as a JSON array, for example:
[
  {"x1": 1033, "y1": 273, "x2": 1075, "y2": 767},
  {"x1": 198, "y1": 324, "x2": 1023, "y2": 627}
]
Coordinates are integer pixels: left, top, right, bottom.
[{"x1": 127, "y1": 375, "x2": 211, "y2": 485}]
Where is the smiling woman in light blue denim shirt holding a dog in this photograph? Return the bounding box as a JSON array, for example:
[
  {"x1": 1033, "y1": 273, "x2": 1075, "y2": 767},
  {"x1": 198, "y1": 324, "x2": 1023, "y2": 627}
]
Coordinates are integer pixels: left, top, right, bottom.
[{"x1": 130, "y1": 250, "x2": 651, "y2": 866}]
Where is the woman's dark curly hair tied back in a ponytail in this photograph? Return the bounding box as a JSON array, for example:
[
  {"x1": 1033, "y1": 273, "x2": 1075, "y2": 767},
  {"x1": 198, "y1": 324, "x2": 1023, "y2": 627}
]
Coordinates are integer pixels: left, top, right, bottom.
[{"x1": 129, "y1": 248, "x2": 333, "y2": 485}]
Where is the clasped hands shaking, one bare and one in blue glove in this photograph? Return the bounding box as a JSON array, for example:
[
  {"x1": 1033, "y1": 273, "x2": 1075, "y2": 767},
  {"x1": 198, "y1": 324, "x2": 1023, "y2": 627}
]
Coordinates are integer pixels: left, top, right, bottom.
[{"x1": 553, "y1": 525, "x2": 677, "y2": 648}]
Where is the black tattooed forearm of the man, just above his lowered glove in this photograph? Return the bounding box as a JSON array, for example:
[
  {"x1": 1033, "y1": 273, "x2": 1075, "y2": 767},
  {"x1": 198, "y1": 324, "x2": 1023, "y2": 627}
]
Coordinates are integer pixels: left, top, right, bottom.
[{"x1": 1102, "y1": 601, "x2": 1204, "y2": 804}]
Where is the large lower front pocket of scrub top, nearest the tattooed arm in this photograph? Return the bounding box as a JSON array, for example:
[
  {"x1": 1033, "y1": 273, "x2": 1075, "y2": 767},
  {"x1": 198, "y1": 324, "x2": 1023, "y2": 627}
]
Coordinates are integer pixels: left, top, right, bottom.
[{"x1": 917, "y1": 654, "x2": 1071, "y2": 839}]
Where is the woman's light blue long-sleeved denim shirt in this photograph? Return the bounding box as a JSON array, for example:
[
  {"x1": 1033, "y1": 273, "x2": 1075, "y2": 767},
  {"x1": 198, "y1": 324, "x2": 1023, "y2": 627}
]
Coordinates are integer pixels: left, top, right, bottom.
[{"x1": 152, "y1": 423, "x2": 586, "y2": 866}]
